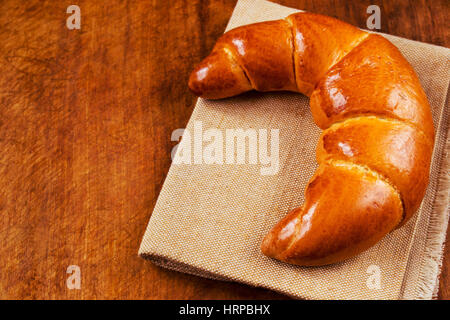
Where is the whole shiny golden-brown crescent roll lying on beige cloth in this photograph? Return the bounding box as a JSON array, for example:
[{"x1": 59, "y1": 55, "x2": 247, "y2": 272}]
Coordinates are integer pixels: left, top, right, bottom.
[{"x1": 189, "y1": 13, "x2": 434, "y2": 266}]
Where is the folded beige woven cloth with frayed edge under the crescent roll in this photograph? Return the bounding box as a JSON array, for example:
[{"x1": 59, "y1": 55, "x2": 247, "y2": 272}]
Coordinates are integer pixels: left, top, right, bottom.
[{"x1": 139, "y1": 0, "x2": 450, "y2": 299}]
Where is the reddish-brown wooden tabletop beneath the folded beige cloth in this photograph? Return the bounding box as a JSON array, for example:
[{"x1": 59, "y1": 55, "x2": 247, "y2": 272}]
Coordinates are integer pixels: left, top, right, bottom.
[{"x1": 0, "y1": 0, "x2": 450, "y2": 299}]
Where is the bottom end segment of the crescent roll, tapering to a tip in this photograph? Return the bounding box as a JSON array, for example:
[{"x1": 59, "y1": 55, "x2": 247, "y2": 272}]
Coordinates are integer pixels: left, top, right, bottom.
[{"x1": 262, "y1": 161, "x2": 403, "y2": 266}]
